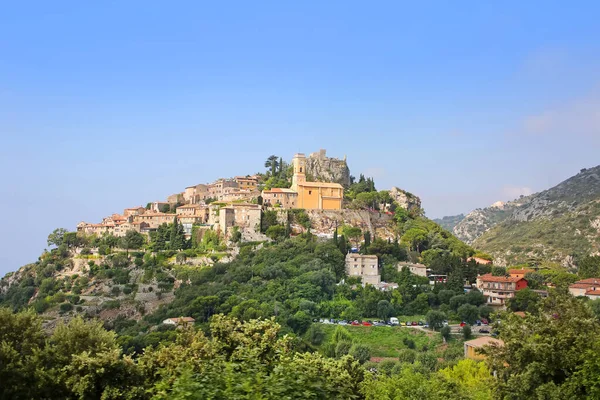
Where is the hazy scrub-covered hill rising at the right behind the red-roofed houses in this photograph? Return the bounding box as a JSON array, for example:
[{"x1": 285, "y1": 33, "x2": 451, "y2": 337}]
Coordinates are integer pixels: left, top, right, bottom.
[{"x1": 452, "y1": 166, "x2": 600, "y2": 265}]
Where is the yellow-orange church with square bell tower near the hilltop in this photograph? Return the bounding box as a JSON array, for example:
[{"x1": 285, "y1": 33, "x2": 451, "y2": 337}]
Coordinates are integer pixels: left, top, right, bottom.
[{"x1": 262, "y1": 153, "x2": 344, "y2": 210}]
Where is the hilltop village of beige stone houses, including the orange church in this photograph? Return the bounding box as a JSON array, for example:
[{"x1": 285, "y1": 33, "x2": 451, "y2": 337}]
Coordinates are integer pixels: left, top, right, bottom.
[{"x1": 77, "y1": 150, "x2": 349, "y2": 238}]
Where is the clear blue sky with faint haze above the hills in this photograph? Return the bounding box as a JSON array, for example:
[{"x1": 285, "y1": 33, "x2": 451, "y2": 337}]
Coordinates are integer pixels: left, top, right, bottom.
[{"x1": 0, "y1": 0, "x2": 600, "y2": 275}]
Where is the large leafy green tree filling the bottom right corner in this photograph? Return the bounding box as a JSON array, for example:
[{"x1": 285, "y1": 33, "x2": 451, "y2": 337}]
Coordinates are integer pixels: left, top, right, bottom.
[{"x1": 484, "y1": 291, "x2": 600, "y2": 399}]
